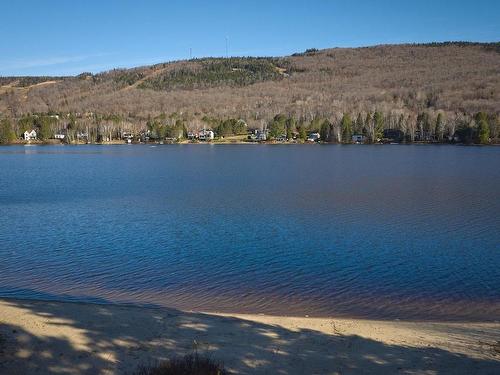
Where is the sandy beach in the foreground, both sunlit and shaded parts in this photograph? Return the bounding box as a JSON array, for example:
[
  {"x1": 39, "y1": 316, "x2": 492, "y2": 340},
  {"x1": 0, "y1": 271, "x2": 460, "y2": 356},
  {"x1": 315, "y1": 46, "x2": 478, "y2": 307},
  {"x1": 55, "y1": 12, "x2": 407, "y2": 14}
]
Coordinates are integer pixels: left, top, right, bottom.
[{"x1": 0, "y1": 299, "x2": 500, "y2": 375}]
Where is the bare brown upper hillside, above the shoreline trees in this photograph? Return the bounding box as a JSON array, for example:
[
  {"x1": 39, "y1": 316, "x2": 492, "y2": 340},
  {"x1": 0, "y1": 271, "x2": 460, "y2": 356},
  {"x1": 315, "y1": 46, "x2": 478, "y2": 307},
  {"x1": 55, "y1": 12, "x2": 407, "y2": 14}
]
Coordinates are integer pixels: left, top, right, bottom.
[{"x1": 0, "y1": 43, "x2": 500, "y2": 122}]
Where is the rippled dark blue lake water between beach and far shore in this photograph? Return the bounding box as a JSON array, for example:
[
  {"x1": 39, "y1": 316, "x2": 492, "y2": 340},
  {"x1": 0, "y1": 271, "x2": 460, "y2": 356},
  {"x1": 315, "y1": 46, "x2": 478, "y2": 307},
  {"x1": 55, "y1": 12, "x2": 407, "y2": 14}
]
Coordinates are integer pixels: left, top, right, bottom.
[{"x1": 0, "y1": 145, "x2": 500, "y2": 320}]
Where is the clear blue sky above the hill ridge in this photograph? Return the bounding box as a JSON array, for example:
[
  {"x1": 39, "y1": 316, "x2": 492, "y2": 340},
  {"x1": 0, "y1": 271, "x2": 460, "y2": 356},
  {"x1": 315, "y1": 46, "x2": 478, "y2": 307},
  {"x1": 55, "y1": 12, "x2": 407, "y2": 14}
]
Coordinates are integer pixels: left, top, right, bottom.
[{"x1": 0, "y1": 0, "x2": 500, "y2": 76}]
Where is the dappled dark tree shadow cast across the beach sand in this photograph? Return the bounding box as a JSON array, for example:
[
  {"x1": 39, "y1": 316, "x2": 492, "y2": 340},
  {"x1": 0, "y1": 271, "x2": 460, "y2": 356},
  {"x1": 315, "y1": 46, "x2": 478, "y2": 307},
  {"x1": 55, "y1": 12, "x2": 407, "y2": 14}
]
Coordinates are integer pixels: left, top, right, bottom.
[{"x1": 0, "y1": 300, "x2": 500, "y2": 375}]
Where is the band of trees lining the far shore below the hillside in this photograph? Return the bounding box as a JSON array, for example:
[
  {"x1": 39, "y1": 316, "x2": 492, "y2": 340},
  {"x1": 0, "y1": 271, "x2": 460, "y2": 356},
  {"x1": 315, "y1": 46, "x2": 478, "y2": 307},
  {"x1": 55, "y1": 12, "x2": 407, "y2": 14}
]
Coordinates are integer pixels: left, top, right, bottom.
[{"x1": 0, "y1": 111, "x2": 500, "y2": 144}]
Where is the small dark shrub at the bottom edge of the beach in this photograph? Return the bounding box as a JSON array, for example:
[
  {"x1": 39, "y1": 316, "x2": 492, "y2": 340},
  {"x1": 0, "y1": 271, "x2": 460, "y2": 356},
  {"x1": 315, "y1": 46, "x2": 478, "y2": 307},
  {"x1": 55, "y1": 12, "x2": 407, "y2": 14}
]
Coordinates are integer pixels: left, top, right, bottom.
[{"x1": 134, "y1": 354, "x2": 228, "y2": 375}]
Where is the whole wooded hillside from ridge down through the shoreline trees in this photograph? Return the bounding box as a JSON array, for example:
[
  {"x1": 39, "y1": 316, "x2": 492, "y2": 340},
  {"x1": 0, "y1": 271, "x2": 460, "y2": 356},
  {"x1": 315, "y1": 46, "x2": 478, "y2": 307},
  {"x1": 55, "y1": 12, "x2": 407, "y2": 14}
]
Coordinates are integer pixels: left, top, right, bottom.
[{"x1": 0, "y1": 43, "x2": 500, "y2": 141}]
